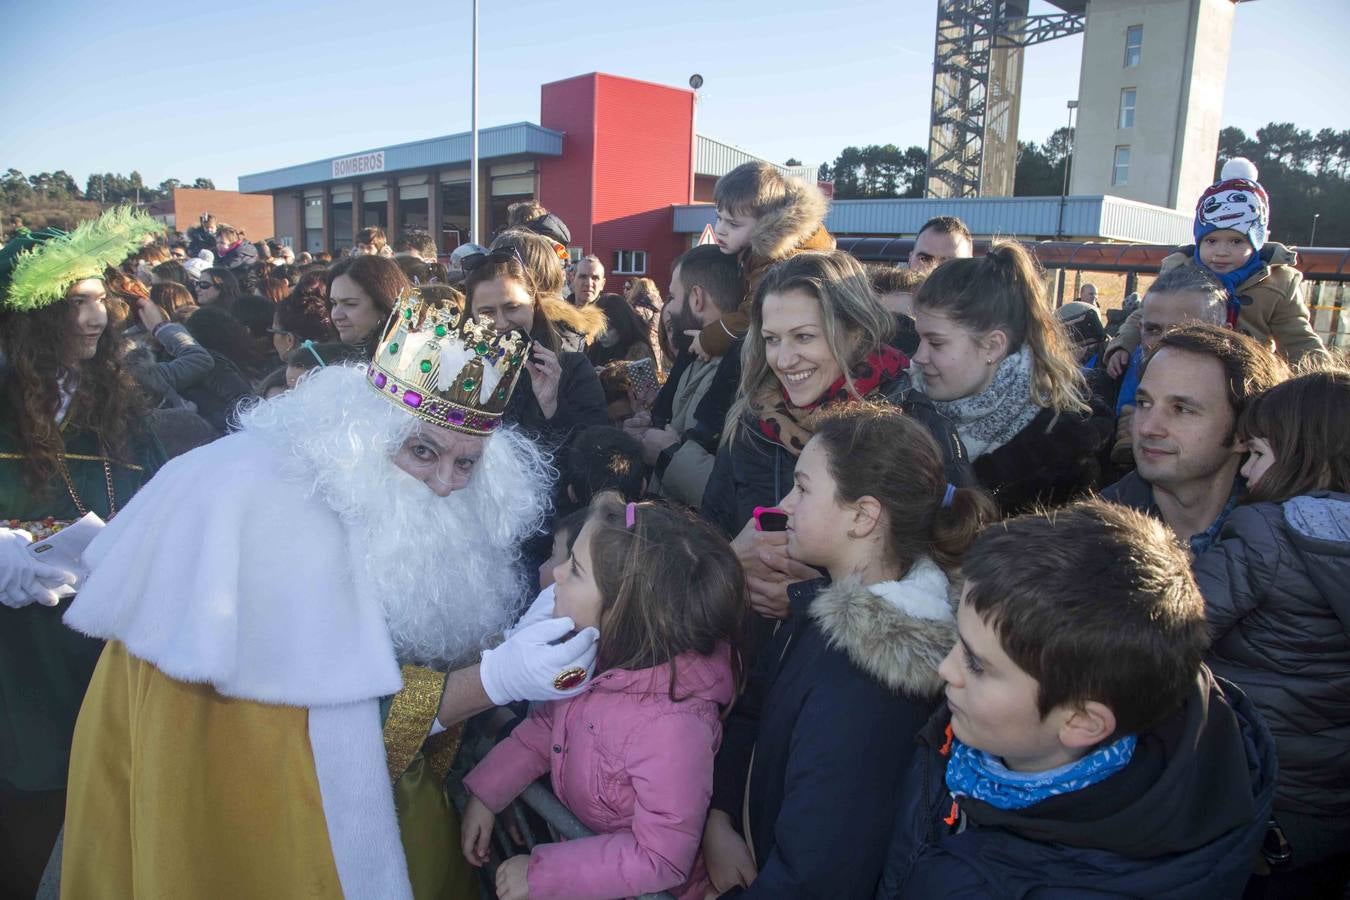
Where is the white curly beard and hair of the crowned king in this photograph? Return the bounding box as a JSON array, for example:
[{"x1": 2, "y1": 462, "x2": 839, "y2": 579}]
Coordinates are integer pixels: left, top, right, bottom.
[{"x1": 240, "y1": 366, "x2": 554, "y2": 668}]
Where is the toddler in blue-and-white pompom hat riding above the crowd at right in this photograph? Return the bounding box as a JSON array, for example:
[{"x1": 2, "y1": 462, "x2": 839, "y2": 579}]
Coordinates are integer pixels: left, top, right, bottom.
[{"x1": 1103, "y1": 158, "x2": 1326, "y2": 376}]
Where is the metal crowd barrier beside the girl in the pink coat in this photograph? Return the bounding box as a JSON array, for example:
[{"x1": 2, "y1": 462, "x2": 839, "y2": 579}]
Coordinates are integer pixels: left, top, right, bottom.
[{"x1": 446, "y1": 719, "x2": 675, "y2": 900}]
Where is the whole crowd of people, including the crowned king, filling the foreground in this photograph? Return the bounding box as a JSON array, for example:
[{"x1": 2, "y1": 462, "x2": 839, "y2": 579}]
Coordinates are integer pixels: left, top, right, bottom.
[{"x1": 0, "y1": 161, "x2": 1350, "y2": 900}]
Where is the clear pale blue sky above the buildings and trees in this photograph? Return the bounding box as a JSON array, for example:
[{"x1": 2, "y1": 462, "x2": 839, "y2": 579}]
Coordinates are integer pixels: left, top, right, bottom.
[{"x1": 0, "y1": 0, "x2": 1350, "y2": 189}]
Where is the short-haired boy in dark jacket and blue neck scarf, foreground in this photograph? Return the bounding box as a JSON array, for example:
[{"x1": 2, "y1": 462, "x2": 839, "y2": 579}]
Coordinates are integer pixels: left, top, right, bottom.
[{"x1": 878, "y1": 501, "x2": 1276, "y2": 899}]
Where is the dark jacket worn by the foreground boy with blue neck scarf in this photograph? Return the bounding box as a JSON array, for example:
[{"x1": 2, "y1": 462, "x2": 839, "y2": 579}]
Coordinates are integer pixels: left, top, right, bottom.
[{"x1": 876, "y1": 668, "x2": 1276, "y2": 900}]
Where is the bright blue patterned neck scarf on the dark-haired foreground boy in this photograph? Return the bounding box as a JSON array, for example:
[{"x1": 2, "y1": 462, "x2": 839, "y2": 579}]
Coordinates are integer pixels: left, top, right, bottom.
[{"x1": 946, "y1": 734, "x2": 1135, "y2": 810}]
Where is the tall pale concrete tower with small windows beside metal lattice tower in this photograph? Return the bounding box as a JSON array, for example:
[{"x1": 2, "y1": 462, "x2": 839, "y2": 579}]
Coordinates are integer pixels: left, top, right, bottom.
[{"x1": 1069, "y1": 0, "x2": 1237, "y2": 212}]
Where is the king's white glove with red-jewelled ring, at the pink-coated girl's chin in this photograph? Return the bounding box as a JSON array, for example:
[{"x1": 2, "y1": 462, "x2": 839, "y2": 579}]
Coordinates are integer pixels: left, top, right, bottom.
[{"x1": 478, "y1": 618, "x2": 599, "y2": 706}]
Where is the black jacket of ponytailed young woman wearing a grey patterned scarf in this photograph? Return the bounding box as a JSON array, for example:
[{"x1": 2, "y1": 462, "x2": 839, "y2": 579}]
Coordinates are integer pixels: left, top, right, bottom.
[{"x1": 972, "y1": 409, "x2": 1115, "y2": 515}]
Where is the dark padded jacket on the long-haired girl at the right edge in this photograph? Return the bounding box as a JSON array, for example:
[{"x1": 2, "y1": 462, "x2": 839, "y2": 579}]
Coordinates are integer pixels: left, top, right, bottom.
[{"x1": 1195, "y1": 491, "x2": 1350, "y2": 854}]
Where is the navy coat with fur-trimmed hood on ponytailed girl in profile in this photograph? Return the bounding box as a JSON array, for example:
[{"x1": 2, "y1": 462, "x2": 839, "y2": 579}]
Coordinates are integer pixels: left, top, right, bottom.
[{"x1": 711, "y1": 560, "x2": 956, "y2": 900}]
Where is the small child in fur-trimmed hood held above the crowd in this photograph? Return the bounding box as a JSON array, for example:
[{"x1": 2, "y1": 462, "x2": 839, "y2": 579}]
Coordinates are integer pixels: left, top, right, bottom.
[{"x1": 694, "y1": 162, "x2": 834, "y2": 358}]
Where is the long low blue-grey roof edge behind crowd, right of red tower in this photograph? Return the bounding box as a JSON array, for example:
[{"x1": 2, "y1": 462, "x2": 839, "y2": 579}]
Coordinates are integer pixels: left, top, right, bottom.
[{"x1": 674, "y1": 196, "x2": 1191, "y2": 244}]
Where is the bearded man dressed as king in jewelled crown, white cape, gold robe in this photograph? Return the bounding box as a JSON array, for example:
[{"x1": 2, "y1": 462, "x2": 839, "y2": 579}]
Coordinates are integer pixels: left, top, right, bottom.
[{"x1": 62, "y1": 291, "x2": 597, "y2": 897}]
